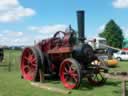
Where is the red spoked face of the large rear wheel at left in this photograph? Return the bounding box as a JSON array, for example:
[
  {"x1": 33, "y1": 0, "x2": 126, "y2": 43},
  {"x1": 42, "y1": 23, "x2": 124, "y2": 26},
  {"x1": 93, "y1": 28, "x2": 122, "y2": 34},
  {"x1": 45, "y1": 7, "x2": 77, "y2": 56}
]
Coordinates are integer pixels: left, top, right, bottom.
[{"x1": 21, "y1": 48, "x2": 37, "y2": 81}]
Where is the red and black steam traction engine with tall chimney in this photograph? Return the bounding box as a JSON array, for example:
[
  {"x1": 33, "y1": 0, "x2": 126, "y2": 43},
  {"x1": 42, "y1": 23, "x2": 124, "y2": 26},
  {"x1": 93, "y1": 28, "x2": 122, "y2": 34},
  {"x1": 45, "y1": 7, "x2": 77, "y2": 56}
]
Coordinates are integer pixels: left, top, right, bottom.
[{"x1": 20, "y1": 11, "x2": 107, "y2": 89}]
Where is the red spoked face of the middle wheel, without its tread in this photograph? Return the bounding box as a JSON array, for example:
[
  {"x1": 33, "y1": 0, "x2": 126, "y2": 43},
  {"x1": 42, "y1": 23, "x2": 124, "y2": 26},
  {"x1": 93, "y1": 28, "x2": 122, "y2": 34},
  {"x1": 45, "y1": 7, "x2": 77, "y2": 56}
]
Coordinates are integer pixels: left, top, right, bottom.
[{"x1": 60, "y1": 61, "x2": 79, "y2": 89}]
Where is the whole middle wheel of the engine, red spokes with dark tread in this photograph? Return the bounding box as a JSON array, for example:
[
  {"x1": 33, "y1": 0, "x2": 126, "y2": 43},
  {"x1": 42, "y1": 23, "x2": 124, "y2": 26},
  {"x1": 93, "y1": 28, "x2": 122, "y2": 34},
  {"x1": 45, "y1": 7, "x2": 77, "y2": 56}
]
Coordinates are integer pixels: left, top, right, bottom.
[{"x1": 60, "y1": 59, "x2": 81, "y2": 89}]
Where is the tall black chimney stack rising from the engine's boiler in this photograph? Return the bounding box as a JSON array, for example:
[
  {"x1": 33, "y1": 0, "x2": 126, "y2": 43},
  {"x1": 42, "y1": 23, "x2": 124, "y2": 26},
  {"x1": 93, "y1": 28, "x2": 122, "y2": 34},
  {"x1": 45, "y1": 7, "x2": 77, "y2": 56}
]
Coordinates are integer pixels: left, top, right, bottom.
[{"x1": 77, "y1": 10, "x2": 85, "y2": 43}]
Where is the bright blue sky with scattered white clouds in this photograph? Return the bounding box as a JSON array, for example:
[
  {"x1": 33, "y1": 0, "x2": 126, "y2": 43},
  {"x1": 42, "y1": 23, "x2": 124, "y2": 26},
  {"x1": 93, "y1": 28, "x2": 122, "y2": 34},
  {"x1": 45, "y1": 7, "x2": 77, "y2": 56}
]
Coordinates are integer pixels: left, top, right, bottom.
[{"x1": 0, "y1": 0, "x2": 128, "y2": 46}]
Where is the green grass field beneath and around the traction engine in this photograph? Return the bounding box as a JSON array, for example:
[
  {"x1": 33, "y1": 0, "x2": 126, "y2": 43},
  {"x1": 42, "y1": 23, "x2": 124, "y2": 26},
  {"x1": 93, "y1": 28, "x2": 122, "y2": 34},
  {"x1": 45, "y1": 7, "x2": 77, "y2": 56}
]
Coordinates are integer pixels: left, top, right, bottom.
[{"x1": 0, "y1": 50, "x2": 128, "y2": 96}]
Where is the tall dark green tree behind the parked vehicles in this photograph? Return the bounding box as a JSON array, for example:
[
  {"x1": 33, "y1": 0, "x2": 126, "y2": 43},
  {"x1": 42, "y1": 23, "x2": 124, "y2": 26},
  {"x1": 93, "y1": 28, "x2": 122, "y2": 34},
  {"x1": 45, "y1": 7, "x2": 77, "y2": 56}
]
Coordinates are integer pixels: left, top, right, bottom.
[{"x1": 99, "y1": 20, "x2": 124, "y2": 48}]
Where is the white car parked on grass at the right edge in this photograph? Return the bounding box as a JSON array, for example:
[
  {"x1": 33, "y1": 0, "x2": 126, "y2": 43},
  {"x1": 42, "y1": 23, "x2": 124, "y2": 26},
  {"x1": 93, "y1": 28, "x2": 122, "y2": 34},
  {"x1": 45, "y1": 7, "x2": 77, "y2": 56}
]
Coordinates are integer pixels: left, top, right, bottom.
[{"x1": 113, "y1": 51, "x2": 128, "y2": 61}]
